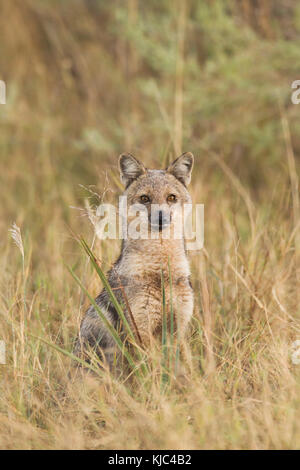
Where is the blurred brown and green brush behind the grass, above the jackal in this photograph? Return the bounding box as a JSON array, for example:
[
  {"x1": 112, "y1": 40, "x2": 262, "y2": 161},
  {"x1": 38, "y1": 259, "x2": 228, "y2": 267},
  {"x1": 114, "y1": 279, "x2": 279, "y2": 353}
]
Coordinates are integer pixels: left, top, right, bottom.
[{"x1": 0, "y1": 0, "x2": 300, "y2": 238}]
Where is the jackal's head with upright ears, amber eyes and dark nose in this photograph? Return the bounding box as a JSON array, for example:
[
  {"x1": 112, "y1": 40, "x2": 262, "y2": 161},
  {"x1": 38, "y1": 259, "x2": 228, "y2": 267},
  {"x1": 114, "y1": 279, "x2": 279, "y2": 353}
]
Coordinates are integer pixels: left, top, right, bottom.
[{"x1": 119, "y1": 152, "x2": 194, "y2": 232}]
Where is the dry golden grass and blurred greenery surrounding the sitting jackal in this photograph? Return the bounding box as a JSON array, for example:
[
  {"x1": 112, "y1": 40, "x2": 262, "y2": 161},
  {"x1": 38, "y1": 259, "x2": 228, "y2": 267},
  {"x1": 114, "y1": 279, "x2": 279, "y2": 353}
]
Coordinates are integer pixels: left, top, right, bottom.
[{"x1": 0, "y1": 0, "x2": 300, "y2": 449}]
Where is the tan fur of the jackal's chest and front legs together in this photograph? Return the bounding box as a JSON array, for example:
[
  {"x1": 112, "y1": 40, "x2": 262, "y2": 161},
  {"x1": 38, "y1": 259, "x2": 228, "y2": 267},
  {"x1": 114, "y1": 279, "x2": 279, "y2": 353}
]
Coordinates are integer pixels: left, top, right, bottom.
[{"x1": 121, "y1": 238, "x2": 193, "y2": 344}]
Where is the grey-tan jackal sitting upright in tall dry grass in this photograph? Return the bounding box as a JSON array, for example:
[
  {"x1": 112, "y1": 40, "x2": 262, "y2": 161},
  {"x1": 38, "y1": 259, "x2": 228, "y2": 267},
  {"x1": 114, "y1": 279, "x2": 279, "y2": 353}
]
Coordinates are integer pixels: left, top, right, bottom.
[{"x1": 75, "y1": 153, "x2": 194, "y2": 366}]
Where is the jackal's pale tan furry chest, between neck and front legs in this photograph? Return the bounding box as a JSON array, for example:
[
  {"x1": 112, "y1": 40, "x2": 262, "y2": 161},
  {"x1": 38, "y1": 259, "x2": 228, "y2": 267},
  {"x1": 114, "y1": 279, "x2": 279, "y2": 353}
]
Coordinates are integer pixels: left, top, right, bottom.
[{"x1": 116, "y1": 243, "x2": 193, "y2": 332}]
